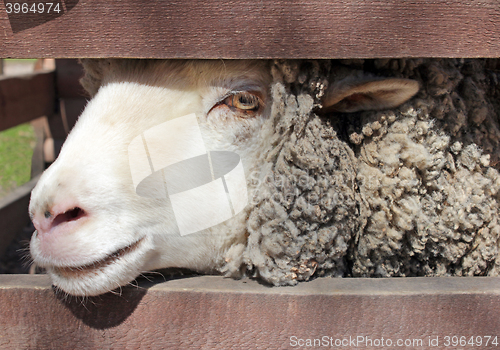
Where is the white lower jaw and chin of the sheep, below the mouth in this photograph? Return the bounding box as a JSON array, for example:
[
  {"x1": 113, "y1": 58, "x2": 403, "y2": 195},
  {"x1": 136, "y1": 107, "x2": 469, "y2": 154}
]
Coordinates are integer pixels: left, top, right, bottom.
[{"x1": 46, "y1": 237, "x2": 148, "y2": 297}]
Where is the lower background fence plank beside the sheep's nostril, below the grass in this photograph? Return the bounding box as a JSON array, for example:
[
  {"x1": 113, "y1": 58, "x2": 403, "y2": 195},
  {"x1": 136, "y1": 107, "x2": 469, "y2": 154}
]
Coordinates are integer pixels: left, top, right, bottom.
[{"x1": 0, "y1": 175, "x2": 40, "y2": 255}]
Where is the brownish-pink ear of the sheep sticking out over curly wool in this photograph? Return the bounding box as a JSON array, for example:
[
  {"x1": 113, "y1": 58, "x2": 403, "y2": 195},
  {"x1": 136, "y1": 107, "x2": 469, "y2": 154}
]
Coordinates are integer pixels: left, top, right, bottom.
[{"x1": 323, "y1": 78, "x2": 419, "y2": 113}]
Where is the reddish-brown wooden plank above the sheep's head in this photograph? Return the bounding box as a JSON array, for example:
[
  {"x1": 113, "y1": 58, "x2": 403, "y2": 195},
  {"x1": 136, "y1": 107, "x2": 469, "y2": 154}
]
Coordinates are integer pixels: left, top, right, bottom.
[{"x1": 0, "y1": 0, "x2": 500, "y2": 58}]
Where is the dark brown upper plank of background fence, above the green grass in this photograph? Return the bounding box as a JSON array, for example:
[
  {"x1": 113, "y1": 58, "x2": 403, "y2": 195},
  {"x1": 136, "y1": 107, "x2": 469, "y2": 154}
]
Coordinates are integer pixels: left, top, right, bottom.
[{"x1": 0, "y1": 72, "x2": 55, "y2": 131}]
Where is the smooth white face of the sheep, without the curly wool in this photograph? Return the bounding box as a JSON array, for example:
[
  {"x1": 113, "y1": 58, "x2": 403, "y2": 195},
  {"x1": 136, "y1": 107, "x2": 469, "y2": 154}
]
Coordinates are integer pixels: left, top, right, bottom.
[{"x1": 30, "y1": 61, "x2": 270, "y2": 295}]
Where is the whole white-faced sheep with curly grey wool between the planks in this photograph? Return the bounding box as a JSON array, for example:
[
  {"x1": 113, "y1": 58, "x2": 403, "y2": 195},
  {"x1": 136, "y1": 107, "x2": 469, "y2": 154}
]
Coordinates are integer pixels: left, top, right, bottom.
[{"x1": 29, "y1": 59, "x2": 500, "y2": 296}]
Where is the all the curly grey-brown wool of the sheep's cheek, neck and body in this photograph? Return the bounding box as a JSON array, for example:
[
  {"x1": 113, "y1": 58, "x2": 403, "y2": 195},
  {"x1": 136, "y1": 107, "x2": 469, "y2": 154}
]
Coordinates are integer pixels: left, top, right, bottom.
[{"x1": 233, "y1": 59, "x2": 500, "y2": 285}]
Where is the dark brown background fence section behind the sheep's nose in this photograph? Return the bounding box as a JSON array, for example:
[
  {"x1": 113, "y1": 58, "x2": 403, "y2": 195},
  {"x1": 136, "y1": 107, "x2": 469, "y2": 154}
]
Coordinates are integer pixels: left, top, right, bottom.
[{"x1": 0, "y1": 59, "x2": 85, "y2": 255}]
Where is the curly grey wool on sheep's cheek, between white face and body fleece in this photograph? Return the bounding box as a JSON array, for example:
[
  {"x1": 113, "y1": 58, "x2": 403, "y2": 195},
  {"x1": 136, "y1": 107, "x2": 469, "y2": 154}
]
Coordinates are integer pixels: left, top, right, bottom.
[{"x1": 238, "y1": 61, "x2": 360, "y2": 285}]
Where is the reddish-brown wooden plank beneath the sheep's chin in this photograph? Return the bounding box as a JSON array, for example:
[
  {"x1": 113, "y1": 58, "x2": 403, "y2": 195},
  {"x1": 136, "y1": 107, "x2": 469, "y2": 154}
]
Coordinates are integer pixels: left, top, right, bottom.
[{"x1": 0, "y1": 275, "x2": 500, "y2": 349}]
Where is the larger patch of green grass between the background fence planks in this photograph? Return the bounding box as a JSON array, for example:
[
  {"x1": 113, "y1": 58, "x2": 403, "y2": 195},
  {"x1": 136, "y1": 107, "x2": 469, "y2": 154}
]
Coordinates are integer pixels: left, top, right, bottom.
[{"x1": 0, "y1": 124, "x2": 36, "y2": 197}]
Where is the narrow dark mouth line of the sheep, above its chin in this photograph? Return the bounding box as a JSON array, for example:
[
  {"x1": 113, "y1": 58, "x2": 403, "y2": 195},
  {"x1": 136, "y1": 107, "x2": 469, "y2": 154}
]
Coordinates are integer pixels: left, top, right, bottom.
[{"x1": 52, "y1": 237, "x2": 144, "y2": 278}]
